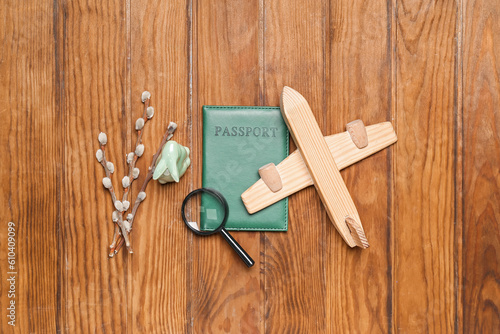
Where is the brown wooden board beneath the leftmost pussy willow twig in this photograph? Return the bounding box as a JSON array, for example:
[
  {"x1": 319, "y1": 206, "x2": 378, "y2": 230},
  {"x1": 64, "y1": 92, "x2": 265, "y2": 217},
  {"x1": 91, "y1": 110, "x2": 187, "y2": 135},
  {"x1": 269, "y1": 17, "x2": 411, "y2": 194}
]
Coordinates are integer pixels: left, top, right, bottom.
[{"x1": 58, "y1": 0, "x2": 130, "y2": 332}]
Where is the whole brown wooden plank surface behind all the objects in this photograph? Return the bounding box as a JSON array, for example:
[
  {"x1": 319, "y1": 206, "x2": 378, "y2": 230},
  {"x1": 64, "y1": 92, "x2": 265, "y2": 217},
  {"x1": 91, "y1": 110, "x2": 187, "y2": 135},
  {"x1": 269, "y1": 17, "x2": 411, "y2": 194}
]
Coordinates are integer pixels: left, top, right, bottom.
[{"x1": 0, "y1": 0, "x2": 500, "y2": 333}]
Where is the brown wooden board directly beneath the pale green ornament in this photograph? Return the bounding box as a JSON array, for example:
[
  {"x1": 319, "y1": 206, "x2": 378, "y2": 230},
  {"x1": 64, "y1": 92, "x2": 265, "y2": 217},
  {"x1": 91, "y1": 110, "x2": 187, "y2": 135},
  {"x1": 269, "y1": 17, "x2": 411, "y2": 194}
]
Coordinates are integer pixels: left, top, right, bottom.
[{"x1": 129, "y1": 0, "x2": 189, "y2": 333}]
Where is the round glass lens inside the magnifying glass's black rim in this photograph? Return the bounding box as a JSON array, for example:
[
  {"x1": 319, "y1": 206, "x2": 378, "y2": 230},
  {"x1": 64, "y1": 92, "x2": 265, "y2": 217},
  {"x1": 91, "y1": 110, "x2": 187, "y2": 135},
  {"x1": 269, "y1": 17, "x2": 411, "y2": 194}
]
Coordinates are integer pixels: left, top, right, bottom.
[{"x1": 184, "y1": 192, "x2": 226, "y2": 232}]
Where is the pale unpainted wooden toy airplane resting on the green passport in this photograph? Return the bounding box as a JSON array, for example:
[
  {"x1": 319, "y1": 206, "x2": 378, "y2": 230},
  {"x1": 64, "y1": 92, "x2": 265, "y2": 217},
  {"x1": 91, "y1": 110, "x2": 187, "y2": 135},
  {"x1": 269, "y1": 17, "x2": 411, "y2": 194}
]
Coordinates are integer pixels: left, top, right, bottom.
[{"x1": 241, "y1": 87, "x2": 397, "y2": 248}]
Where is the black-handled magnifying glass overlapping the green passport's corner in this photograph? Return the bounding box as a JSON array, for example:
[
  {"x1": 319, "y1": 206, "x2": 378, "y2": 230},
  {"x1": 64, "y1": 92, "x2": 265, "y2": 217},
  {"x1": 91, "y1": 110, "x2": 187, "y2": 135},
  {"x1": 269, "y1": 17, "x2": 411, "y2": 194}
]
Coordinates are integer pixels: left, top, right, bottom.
[{"x1": 181, "y1": 188, "x2": 255, "y2": 267}]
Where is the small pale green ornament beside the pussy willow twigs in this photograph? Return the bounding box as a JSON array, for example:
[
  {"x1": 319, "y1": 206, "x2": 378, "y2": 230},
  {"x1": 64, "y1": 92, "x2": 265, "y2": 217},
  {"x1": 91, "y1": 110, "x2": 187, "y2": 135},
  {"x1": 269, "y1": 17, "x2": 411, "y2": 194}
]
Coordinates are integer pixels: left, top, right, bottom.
[{"x1": 153, "y1": 140, "x2": 191, "y2": 184}]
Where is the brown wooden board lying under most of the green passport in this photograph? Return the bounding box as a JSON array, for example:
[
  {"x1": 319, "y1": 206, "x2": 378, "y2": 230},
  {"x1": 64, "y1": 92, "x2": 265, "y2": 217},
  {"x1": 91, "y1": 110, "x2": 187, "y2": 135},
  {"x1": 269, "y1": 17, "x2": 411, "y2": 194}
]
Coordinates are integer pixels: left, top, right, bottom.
[{"x1": 188, "y1": 0, "x2": 264, "y2": 333}]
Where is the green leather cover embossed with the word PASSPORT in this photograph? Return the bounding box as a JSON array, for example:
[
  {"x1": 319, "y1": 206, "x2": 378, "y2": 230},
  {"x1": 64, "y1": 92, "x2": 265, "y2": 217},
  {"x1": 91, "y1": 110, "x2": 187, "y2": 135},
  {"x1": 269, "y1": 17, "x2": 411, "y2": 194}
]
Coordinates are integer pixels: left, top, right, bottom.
[{"x1": 200, "y1": 106, "x2": 289, "y2": 231}]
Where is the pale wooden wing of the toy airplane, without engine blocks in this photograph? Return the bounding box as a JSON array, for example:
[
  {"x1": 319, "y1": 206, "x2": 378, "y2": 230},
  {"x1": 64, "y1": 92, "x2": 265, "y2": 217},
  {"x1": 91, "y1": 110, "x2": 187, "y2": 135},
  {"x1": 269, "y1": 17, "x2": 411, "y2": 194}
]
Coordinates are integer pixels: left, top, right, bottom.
[{"x1": 241, "y1": 122, "x2": 397, "y2": 213}]
